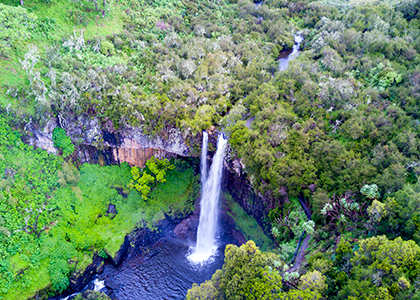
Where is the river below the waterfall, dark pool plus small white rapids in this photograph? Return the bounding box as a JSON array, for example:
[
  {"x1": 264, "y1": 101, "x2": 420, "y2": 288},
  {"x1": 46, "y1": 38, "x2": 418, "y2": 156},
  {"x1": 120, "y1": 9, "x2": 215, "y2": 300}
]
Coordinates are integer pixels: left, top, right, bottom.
[{"x1": 57, "y1": 203, "x2": 245, "y2": 300}]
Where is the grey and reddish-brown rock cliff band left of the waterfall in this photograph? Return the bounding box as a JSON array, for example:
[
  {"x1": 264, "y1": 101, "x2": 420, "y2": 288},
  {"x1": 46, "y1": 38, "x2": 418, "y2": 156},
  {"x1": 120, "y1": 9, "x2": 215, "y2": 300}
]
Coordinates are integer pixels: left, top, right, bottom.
[{"x1": 28, "y1": 116, "x2": 191, "y2": 167}]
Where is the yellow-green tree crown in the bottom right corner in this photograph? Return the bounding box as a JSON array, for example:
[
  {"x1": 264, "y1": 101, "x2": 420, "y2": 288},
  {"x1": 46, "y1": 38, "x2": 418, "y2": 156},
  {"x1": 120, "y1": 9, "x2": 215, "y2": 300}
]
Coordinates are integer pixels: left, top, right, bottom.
[{"x1": 326, "y1": 236, "x2": 420, "y2": 299}]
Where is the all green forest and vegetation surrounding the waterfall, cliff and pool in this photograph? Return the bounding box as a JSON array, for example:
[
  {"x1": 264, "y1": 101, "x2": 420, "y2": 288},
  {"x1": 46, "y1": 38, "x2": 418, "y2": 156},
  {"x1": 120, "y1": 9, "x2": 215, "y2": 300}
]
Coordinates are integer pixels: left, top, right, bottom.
[{"x1": 0, "y1": 0, "x2": 420, "y2": 300}]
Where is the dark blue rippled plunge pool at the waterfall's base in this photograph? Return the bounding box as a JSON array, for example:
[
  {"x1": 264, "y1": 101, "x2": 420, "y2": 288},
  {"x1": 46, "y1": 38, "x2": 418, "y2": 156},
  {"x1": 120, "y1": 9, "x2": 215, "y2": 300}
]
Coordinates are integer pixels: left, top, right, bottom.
[{"x1": 98, "y1": 238, "x2": 224, "y2": 300}]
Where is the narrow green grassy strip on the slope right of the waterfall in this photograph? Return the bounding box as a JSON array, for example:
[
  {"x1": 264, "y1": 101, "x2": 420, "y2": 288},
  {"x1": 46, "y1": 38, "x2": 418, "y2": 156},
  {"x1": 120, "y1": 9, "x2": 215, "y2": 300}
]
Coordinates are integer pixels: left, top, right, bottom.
[{"x1": 225, "y1": 194, "x2": 275, "y2": 251}]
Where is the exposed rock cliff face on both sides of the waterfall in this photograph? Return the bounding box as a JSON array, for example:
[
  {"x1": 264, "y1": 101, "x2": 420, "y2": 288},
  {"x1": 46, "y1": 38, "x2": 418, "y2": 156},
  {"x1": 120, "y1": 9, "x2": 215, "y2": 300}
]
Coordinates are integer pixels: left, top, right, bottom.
[{"x1": 28, "y1": 117, "x2": 268, "y2": 231}]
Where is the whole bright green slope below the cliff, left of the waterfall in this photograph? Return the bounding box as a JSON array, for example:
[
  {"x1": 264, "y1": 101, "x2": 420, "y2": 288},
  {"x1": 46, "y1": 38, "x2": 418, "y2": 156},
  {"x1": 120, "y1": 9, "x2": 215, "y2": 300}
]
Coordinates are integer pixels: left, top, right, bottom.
[{"x1": 0, "y1": 112, "x2": 198, "y2": 299}]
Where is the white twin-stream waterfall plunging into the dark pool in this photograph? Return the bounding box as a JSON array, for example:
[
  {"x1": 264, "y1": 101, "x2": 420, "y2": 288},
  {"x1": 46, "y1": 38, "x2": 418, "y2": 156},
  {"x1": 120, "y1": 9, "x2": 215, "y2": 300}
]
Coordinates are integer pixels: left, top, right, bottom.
[{"x1": 190, "y1": 135, "x2": 227, "y2": 263}]
